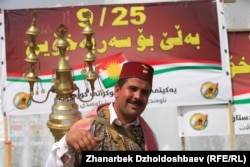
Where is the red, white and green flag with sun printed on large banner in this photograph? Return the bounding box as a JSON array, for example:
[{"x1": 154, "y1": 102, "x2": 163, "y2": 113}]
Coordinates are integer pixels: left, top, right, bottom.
[{"x1": 96, "y1": 53, "x2": 127, "y2": 88}]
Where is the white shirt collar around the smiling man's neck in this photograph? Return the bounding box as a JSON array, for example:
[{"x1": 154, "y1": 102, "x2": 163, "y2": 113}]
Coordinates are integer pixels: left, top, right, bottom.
[{"x1": 109, "y1": 103, "x2": 140, "y2": 128}]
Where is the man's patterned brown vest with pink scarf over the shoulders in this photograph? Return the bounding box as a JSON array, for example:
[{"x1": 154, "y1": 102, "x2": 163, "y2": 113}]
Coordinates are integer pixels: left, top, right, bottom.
[{"x1": 71, "y1": 104, "x2": 158, "y2": 151}]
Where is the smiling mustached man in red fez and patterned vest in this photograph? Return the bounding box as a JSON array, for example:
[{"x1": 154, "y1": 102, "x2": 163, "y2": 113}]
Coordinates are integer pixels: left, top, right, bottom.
[{"x1": 46, "y1": 62, "x2": 158, "y2": 167}]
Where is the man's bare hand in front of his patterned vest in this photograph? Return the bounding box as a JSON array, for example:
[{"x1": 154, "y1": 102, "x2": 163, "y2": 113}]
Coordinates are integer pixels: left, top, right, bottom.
[{"x1": 66, "y1": 130, "x2": 102, "y2": 154}]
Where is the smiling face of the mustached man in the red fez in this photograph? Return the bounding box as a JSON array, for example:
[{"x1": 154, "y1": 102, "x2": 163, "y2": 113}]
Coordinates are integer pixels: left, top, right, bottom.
[{"x1": 114, "y1": 78, "x2": 151, "y2": 123}]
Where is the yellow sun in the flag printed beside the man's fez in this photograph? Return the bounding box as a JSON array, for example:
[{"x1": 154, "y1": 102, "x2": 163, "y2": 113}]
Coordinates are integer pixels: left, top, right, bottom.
[{"x1": 106, "y1": 61, "x2": 121, "y2": 80}]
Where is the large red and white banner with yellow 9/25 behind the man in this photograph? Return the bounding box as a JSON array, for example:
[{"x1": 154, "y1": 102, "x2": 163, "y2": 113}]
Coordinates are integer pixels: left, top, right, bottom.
[{"x1": 4, "y1": 0, "x2": 232, "y2": 114}]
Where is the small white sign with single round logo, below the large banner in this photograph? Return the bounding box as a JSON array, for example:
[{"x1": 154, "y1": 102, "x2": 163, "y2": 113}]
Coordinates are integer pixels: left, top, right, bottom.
[{"x1": 178, "y1": 105, "x2": 229, "y2": 137}]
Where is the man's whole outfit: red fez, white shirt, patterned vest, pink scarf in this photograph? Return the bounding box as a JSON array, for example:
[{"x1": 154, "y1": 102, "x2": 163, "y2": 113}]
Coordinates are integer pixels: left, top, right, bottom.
[{"x1": 46, "y1": 62, "x2": 158, "y2": 167}]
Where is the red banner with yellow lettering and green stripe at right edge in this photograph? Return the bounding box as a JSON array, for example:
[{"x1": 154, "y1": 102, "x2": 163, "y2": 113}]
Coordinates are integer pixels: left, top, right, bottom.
[{"x1": 228, "y1": 31, "x2": 250, "y2": 104}]
